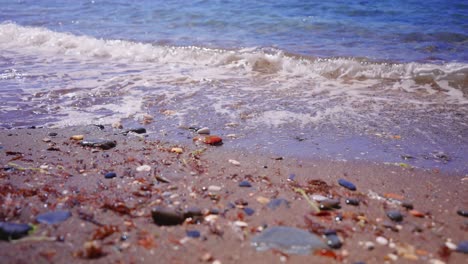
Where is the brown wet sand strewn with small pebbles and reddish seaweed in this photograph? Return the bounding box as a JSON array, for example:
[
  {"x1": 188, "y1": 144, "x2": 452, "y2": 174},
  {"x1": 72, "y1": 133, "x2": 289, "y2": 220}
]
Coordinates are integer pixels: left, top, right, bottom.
[{"x1": 0, "y1": 126, "x2": 468, "y2": 263}]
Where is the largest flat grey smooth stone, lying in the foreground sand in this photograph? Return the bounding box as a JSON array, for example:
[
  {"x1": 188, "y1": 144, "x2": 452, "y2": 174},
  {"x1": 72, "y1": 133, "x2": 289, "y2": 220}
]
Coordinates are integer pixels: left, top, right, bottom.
[{"x1": 251, "y1": 226, "x2": 326, "y2": 255}]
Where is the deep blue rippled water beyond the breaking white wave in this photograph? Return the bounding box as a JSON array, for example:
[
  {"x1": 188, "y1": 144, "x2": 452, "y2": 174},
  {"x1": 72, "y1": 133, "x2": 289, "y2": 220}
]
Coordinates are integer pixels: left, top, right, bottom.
[{"x1": 0, "y1": 0, "x2": 468, "y2": 62}]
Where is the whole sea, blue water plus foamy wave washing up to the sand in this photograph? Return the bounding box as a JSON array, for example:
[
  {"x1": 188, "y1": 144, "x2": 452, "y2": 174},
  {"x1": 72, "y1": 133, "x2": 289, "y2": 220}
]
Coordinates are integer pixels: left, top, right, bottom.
[{"x1": 0, "y1": 0, "x2": 468, "y2": 173}]
